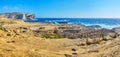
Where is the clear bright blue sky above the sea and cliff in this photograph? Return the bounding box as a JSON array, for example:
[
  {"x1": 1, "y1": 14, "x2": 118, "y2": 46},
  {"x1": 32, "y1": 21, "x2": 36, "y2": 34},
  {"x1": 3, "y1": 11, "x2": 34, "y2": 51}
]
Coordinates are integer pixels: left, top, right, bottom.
[{"x1": 0, "y1": 0, "x2": 120, "y2": 18}]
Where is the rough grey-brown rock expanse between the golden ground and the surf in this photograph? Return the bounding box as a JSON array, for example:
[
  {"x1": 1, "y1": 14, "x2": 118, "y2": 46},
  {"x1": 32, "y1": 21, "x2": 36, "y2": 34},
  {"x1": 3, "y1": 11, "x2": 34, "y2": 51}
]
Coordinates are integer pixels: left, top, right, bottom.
[{"x1": 54, "y1": 24, "x2": 115, "y2": 39}]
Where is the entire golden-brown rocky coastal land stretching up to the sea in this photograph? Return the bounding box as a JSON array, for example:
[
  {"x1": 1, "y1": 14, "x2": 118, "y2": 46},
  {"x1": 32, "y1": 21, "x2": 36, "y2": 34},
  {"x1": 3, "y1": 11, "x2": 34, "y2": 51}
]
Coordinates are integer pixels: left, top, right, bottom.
[{"x1": 0, "y1": 18, "x2": 120, "y2": 57}]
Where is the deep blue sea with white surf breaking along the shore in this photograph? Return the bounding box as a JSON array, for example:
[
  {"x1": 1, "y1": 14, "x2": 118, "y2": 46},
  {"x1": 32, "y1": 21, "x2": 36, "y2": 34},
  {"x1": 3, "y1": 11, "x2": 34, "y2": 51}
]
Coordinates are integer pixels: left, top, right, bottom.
[{"x1": 27, "y1": 18, "x2": 120, "y2": 29}]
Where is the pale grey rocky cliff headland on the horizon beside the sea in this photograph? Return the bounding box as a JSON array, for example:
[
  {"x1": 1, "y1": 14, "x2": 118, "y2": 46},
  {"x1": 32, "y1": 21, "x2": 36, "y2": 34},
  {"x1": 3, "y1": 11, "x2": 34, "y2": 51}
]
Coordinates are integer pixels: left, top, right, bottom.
[{"x1": 0, "y1": 12, "x2": 35, "y2": 20}]
